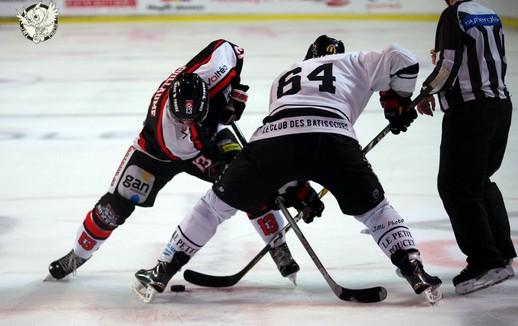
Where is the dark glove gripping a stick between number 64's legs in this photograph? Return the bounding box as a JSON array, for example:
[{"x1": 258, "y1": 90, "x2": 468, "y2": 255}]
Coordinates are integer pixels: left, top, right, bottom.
[{"x1": 282, "y1": 181, "x2": 324, "y2": 223}]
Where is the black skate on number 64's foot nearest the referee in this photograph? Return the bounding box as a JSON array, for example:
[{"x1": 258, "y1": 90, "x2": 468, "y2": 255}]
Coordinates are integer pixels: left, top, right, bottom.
[{"x1": 390, "y1": 250, "x2": 442, "y2": 304}]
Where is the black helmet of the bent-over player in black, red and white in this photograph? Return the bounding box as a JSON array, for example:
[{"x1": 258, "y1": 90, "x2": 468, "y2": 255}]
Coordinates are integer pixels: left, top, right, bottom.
[{"x1": 169, "y1": 73, "x2": 209, "y2": 122}]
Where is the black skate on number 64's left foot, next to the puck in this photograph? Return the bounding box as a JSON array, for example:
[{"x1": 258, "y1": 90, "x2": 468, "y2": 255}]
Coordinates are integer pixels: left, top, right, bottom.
[{"x1": 133, "y1": 252, "x2": 190, "y2": 303}]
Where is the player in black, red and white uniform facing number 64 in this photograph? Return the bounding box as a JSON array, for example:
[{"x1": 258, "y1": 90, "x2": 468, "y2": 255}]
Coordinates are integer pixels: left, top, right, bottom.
[{"x1": 49, "y1": 40, "x2": 299, "y2": 286}]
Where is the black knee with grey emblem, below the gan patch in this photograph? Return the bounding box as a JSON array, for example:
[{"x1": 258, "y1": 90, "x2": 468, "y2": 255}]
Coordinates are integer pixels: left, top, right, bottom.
[{"x1": 93, "y1": 193, "x2": 135, "y2": 230}]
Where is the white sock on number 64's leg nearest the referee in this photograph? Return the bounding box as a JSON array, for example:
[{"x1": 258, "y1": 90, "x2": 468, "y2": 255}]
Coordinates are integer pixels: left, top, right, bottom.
[{"x1": 355, "y1": 199, "x2": 416, "y2": 258}]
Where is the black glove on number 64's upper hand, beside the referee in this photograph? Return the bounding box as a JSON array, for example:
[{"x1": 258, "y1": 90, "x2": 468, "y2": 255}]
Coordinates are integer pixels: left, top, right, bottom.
[{"x1": 379, "y1": 89, "x2": 417, "y2": 135}]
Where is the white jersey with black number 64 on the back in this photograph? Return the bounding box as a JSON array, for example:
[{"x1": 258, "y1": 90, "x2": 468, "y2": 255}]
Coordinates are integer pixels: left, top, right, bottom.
[{"x1": 251, "y1": 45, "x2": 418, "y2": 141}]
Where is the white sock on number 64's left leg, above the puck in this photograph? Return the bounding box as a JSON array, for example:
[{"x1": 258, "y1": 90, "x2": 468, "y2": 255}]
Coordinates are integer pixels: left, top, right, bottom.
[{"x1": 159, "y1": 189, "x2": 237, "y2": 262}]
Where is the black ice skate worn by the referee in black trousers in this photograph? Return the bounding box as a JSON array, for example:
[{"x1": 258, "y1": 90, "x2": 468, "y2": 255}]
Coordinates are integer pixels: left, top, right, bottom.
[{"x1": 453, "y1": 264, "x2": 514, "y2": 294}]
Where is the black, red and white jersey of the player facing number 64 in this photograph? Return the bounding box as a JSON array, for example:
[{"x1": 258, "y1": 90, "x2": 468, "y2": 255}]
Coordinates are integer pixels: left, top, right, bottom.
[{"x1": 135, "y1": 40, "x2": 244, "y2": 160}]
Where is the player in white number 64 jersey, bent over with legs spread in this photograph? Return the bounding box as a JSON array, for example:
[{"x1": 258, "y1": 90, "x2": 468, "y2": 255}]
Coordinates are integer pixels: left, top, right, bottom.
[{"x1": 136, "y1": 35, "x2": 441, "y2": 300}]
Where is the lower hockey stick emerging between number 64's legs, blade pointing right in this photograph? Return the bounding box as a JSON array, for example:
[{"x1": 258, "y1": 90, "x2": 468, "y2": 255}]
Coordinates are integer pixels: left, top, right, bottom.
[{"x1": 275, "y1": 196, "x2": 387, "y2": 303}]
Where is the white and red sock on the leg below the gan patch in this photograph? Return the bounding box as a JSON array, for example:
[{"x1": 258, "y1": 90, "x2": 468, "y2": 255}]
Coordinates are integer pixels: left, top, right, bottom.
[{"x1": 74, "y1": 211, "x2": 113, "y2": 259}]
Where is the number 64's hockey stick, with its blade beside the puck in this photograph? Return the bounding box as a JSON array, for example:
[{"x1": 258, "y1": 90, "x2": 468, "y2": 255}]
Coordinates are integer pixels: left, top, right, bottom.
[{"x1": 183, "y1": 88, "x2": 431, "y2": 287}]
